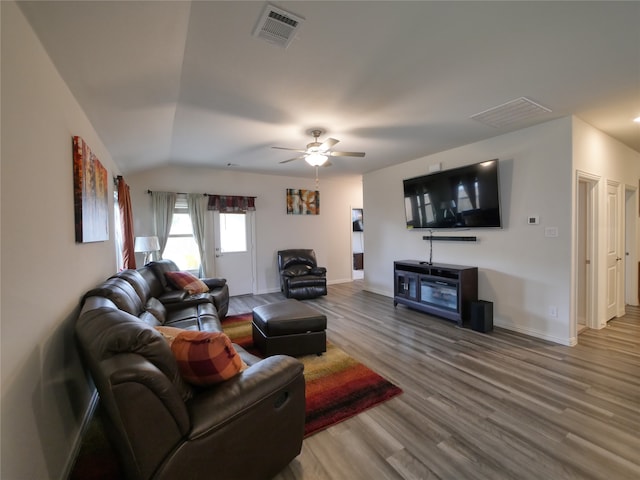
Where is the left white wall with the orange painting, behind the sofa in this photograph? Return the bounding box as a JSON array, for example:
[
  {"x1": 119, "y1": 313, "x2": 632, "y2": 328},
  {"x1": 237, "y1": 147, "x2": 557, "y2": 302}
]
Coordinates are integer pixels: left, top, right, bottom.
[{"x1": 0, "y1": 1, "x2": 122, "y2": 480}]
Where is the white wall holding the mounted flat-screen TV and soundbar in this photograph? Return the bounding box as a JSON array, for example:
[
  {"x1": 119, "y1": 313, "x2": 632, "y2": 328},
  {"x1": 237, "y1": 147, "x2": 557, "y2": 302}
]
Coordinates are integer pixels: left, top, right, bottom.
[{"x1": 364, "y1": 118, "x2": 575, "y2": 344}]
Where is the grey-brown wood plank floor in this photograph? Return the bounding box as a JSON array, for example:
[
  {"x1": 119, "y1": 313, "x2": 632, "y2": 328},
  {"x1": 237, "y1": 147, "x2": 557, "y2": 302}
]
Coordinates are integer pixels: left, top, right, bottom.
[{"x1": 230, "y1": 281, "x2": 640, "y2": 480}]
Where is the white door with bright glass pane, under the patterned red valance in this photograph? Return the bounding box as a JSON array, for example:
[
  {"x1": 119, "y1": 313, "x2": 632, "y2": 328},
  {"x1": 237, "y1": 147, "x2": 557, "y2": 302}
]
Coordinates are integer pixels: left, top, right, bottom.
[{"x1": 213, "y1": 212, "x2": 255, "y2": 296}]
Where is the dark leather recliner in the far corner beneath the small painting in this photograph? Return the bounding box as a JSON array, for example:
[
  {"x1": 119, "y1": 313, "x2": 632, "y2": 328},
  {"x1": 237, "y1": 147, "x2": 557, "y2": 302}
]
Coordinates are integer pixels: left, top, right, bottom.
[{"x1": 278, "y1": 249, "x2": 327, "y2": 300}]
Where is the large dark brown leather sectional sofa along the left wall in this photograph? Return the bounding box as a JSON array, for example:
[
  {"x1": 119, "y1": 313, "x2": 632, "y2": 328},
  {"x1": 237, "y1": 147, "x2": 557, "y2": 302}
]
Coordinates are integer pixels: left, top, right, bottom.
[{"x1": 76, "y1": 261, "x2": 305, "y2": 480}]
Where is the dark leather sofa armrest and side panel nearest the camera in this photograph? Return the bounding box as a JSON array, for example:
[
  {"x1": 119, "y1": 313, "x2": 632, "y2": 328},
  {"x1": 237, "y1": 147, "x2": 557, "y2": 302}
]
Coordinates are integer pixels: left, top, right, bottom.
[{"x1": 153, "y1": 355, "x2": 305, "y2": 480}]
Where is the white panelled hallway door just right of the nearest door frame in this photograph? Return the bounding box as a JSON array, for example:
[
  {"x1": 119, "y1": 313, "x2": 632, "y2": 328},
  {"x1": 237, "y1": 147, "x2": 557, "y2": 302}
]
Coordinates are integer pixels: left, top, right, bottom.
[{"x1": 607, "y1": 183, "x2": 622, "y2": 319}]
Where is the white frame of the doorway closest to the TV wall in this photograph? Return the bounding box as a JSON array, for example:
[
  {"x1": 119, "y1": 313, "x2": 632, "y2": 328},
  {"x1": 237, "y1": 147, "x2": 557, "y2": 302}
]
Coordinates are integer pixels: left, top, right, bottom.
[{"x1": 570, "y1": 170, "x2": 602, "y2": 343}]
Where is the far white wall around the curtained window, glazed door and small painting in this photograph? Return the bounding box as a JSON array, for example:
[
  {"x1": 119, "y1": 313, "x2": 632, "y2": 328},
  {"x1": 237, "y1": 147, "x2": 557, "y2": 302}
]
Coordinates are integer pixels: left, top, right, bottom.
[{"x1": 125, "y1": 167, "x2": 362, "y2": 293}]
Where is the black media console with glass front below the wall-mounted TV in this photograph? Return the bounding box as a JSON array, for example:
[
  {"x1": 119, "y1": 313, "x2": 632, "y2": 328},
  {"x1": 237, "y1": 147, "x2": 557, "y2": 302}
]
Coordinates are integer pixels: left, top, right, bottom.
[{"x1": 393, "y1": 260, "x2": 478, "y2": 326}]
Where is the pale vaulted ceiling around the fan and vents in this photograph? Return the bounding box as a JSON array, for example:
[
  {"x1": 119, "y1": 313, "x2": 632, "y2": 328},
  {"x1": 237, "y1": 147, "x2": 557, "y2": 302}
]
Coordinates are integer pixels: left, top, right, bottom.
[{"x1": 18, "y1": 1, "x2": 640, "y2": 176}]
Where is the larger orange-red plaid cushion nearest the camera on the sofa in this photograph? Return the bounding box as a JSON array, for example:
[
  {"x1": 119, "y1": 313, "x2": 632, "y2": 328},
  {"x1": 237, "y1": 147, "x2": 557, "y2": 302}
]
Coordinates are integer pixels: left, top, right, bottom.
[{"x1": 157, "y1": 327, "x2": 247, "y2": 386}]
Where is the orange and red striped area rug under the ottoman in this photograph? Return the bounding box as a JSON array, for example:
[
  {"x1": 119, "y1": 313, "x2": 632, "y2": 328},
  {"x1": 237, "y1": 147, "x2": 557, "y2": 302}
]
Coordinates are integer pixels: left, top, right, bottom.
[{"x1": 69, "y1": 313, "x2": 402, "y2": 480}]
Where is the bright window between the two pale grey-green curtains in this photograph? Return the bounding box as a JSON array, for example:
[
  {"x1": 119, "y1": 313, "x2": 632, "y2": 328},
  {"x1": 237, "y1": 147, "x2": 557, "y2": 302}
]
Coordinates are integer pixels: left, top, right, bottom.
[{"x1": 162, "y1": 195, "x2": 200, "y2": 272}]
